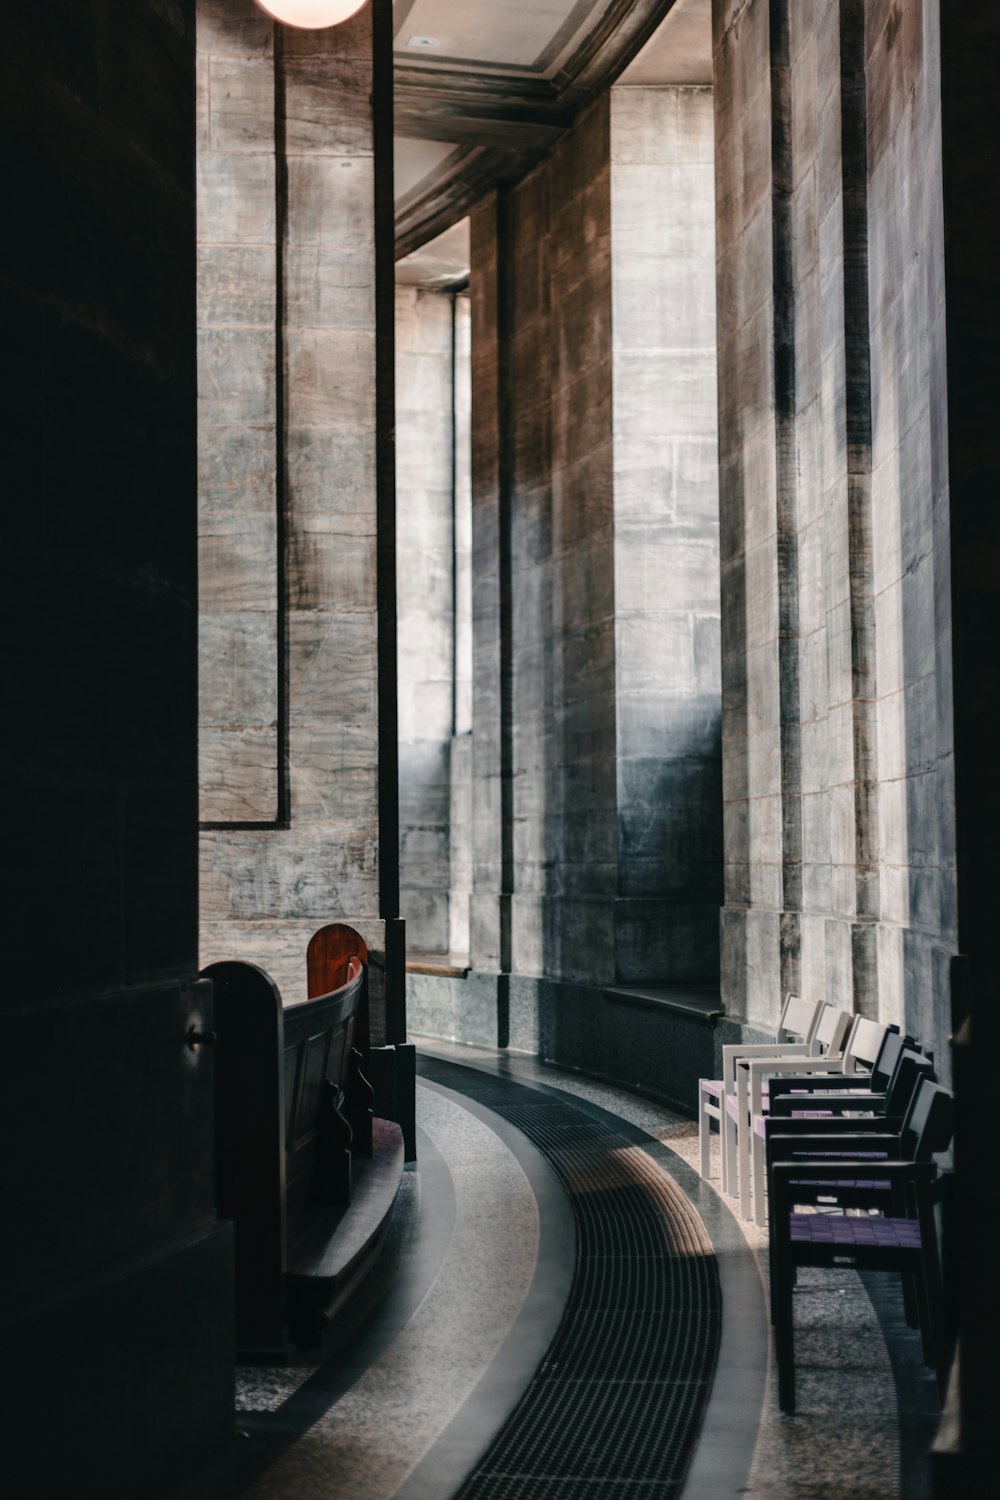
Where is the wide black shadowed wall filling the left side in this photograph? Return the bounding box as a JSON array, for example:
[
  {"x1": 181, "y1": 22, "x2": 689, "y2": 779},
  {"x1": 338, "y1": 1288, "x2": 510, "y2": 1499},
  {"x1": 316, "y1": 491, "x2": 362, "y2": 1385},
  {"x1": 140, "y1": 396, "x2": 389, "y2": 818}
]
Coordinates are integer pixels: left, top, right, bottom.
[{"x1": 0, "y1": 0, "x2": 232, "y2": 1496}]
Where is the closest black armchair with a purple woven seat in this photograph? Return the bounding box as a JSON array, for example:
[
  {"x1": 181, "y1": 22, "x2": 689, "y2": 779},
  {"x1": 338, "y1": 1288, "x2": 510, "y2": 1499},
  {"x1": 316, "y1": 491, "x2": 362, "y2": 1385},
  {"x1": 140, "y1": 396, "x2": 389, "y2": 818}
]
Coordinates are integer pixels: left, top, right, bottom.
[{"x1": 771, "y1": 1077, "x2": 954, "y2": 1412}]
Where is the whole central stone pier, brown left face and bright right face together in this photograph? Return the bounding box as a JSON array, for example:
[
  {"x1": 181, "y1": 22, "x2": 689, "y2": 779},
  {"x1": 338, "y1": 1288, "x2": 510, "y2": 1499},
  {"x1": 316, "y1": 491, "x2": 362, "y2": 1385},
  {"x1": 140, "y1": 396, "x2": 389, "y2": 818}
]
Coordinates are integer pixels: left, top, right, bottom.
[{"x1": 458, "y1": 89, "x2": 721, "y2": 1008}]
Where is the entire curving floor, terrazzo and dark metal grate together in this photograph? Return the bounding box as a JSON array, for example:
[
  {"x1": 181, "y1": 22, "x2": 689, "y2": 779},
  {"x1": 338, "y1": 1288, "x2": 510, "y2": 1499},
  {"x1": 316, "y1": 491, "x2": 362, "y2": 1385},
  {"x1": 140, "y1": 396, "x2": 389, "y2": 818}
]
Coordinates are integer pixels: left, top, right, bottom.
[{"x1": 173, "y1": 1043, "x2": 936, "y2": 1500}]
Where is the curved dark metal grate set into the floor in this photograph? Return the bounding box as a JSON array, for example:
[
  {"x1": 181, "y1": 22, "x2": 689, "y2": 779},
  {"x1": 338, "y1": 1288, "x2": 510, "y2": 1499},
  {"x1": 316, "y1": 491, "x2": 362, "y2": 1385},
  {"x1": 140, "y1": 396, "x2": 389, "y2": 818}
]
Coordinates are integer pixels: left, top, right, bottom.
[{"x1": 420, "y1": 1059, "x2": 721, "y2": 1500}]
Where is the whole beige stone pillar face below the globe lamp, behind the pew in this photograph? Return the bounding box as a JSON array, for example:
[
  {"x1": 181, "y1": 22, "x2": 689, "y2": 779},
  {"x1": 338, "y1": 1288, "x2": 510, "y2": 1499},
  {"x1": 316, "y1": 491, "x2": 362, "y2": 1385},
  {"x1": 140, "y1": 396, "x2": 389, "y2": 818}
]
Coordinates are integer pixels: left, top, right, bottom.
[{"x1": 198, "y1": 0, "x2": 384, "y2": 1035}]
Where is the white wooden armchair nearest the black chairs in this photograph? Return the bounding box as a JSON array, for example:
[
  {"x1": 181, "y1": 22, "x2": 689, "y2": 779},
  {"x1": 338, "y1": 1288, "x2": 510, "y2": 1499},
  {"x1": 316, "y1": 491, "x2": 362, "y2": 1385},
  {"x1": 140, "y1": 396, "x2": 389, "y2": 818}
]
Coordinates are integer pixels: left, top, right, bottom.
[{"x1": 736, "y1": 1007, "x2": 888, "y2": 1227}]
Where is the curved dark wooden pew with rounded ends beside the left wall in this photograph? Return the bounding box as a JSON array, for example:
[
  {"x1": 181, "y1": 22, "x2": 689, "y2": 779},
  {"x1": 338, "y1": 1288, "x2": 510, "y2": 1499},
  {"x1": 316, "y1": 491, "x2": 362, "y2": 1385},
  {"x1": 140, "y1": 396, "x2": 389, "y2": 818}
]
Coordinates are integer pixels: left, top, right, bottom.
[{"x1": 204, "y1": 924, "x2": 403, "y2": 1362}]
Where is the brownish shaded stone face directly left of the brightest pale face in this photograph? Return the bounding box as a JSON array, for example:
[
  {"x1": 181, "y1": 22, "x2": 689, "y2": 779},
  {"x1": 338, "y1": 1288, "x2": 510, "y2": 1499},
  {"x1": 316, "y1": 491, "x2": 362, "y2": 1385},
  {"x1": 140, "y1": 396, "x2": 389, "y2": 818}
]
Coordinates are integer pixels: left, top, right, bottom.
[{"x1": 512, "y1": 96, "x2": 618, "y2": 983}]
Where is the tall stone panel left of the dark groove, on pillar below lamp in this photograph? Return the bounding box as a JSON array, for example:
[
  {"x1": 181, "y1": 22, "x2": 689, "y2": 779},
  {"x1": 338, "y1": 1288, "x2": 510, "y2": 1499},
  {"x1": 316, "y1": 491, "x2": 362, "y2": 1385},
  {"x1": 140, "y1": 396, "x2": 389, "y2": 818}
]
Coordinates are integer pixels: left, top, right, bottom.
[{"x1": 198, "y1": 3, "x2": 279, "y2": 822}]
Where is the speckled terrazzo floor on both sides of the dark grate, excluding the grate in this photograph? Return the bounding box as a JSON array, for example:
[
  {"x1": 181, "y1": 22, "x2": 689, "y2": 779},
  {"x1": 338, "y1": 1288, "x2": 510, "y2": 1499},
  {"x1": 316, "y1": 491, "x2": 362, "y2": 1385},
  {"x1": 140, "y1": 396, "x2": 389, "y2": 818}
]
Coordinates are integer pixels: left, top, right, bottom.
[{"x1": 177, "y1": 1040, "x2": 936, "y2": 1500}]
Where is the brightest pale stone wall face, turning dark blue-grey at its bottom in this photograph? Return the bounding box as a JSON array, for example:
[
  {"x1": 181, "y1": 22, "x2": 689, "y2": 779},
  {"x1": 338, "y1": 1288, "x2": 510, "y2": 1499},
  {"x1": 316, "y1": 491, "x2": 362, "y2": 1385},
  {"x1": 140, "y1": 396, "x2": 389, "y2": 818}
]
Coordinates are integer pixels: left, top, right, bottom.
[{"x1": 610, "y1": 87, "x2": 723, "y2": 983}]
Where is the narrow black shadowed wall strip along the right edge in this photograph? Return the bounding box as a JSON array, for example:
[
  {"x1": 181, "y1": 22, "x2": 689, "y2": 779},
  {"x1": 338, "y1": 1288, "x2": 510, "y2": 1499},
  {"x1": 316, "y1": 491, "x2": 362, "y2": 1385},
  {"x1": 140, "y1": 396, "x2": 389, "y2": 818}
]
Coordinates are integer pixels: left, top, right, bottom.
[{"x1": 936, "y1": 0, "x2": 1000, "y2": 1496}]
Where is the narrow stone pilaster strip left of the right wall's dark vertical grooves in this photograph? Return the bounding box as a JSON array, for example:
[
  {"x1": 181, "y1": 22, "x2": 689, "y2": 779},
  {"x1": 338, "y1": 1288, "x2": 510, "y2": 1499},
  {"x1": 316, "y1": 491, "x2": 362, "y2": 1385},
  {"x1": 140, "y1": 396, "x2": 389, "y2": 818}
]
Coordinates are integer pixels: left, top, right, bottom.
[{"x1": 714, "y1": 3, "x2": 783, "y2": 1026}]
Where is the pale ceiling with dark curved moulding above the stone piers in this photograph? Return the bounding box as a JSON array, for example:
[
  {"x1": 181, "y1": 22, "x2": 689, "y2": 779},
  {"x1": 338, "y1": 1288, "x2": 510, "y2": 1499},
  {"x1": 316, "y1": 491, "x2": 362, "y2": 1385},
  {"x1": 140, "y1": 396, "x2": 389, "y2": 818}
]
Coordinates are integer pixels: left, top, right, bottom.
[{"x1": 393, "y1": 0, "x2": 711, "y2": 255}]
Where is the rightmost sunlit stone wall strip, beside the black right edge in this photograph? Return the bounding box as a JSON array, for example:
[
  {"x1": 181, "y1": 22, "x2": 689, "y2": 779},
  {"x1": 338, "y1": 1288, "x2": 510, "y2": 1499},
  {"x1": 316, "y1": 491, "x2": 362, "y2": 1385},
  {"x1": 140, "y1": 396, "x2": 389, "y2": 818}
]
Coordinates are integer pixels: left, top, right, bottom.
[{"x1": 865, "y1": 0, "x2": 958, "y2": 1068}]
